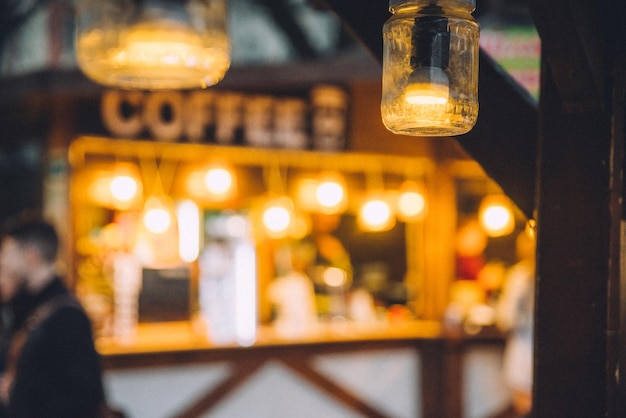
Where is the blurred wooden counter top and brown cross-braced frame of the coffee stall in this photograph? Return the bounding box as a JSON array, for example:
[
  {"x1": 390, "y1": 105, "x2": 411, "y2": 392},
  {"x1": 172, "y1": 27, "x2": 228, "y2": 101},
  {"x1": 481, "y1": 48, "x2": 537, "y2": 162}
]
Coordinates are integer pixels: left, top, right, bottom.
[{"x1": 97, "y1": 321, "x2": 502, "y2": 418}]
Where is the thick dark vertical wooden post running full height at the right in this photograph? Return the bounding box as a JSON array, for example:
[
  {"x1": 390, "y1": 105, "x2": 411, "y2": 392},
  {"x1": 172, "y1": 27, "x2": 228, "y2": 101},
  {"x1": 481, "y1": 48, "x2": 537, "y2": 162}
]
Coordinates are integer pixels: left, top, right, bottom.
[{"x1": 530, "y1": 0, "x2": 624, "y2": 418}]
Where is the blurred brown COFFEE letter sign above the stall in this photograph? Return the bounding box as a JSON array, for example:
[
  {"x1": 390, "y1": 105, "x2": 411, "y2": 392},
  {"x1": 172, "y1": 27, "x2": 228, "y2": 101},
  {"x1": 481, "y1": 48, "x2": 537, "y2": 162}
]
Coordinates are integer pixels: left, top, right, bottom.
[{"x1": 101, "y1": 85, "x2": 348, "y2": 151}]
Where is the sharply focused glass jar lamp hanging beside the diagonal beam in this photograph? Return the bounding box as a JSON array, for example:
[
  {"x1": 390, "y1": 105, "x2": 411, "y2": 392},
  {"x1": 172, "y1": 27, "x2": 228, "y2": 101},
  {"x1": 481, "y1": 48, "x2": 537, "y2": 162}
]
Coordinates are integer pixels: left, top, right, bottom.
[{"x1": 381, "y1": 0, "x2": 480, "y2": 136}]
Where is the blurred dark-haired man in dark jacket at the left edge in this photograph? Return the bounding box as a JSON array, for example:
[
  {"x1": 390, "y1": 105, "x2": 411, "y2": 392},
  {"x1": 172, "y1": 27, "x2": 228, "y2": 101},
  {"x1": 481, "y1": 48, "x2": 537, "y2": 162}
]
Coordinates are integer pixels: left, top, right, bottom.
[{"x1": 0, "y1": 217, "x2": 114, "y2": 418}]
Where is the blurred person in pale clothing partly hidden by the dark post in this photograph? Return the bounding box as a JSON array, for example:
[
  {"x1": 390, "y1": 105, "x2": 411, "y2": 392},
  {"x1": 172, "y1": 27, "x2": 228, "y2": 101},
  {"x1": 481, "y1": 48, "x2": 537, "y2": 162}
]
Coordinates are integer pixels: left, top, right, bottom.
[{"x1": 496, "y1": 231, "x2": 535, "y2": 417}]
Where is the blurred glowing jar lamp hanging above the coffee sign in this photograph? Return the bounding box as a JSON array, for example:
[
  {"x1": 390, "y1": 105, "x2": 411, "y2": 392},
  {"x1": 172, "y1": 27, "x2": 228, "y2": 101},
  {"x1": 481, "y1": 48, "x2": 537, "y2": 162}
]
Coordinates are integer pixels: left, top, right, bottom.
[{"x1": 75, "y1": 0, "x2": 230, "y2": 90}]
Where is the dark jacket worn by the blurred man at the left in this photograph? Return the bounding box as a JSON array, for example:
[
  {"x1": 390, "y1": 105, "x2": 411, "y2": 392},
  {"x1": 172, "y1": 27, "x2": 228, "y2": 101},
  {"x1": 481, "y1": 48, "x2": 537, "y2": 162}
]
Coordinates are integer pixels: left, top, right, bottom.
[{"x1": 0, "y1": 278, "x2": 104, "y2": 418}]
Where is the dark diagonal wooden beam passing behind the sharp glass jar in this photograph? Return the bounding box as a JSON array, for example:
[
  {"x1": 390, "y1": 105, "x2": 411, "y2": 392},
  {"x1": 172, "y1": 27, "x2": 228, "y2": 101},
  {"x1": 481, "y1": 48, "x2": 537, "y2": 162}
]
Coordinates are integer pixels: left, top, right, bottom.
[{"x1": 320, "y1": 0, "x2": 538, "y2": 218}]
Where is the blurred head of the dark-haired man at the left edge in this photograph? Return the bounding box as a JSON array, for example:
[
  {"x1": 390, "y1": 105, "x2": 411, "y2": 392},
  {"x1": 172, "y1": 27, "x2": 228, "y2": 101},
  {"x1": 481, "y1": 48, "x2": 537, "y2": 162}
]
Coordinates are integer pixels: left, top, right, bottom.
[{"x1": 0, "y1": 217, "x2": 59, "y2": 301}]
